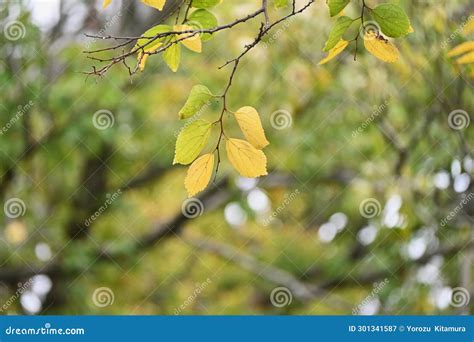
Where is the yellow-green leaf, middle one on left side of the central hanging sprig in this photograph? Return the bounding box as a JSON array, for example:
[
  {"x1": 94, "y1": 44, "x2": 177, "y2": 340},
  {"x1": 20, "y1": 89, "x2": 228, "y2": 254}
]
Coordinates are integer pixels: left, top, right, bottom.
[{"x1": 173, "y1": 120, "x2": 212, "y2": 165}]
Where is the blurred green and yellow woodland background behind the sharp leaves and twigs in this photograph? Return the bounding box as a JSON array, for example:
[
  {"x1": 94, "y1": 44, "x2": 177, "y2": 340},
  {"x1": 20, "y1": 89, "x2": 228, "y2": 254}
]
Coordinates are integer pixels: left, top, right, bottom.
[{"x1": 0, "y1": 0, "x2": 474, "y2": 315}]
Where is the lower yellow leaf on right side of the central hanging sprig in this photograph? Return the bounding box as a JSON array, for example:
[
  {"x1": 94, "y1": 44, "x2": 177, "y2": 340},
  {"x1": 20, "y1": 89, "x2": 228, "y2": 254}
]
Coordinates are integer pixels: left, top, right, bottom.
[{"x1": 226, "y1": 138, "x2": 267, "y2": 178}]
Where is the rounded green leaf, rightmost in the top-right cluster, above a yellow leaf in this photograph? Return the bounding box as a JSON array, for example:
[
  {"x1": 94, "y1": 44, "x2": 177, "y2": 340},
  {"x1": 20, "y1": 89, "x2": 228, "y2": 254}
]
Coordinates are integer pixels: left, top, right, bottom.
[{"x1": 372, "y1": 4, "x2": 410, "y2": 38}]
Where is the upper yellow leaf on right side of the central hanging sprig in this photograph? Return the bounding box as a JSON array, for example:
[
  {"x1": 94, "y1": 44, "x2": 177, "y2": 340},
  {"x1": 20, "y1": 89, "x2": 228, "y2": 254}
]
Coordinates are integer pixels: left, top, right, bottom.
[{"x1": 235, "y1": 106, "x2": 269, "y2": 150}]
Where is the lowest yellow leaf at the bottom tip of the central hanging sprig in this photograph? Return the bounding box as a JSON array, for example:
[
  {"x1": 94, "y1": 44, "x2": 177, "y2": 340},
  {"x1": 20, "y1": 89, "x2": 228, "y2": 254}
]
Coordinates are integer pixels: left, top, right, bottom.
[{"x1": 184, "y1": 153, "x2": 214, "y2": 197}]
